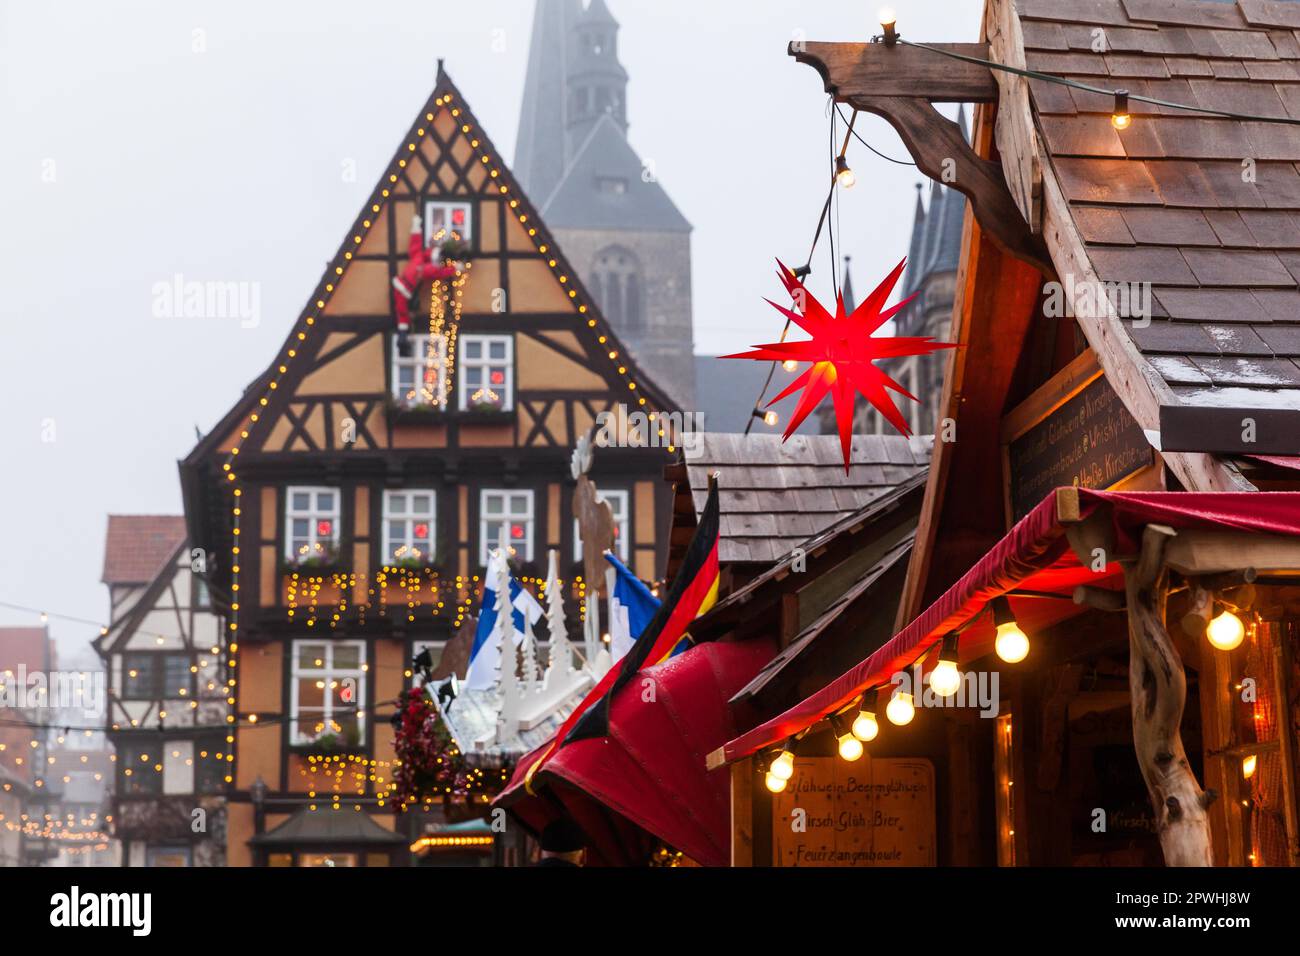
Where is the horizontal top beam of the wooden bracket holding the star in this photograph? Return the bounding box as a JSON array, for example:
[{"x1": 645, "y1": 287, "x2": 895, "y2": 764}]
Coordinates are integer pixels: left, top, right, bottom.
[{"x1": 788, "y1": 40, "x2": 997, "y2": 103}]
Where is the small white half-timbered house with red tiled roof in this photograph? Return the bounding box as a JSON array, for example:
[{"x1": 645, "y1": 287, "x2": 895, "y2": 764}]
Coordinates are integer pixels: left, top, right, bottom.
[{"x1": 95, "y1": 515, "x2": 231, "y2": 866}]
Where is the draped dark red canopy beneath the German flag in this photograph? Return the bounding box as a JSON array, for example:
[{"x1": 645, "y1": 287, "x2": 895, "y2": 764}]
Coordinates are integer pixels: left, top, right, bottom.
[{"x1": 497, "y1": 640, "x2": 775, "y2": 866}]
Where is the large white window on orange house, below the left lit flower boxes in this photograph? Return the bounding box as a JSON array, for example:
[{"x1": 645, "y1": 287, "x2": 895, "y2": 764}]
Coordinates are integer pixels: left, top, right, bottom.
[{"x1": 289, "y1": 641, "x2": 367, "y2": 747}]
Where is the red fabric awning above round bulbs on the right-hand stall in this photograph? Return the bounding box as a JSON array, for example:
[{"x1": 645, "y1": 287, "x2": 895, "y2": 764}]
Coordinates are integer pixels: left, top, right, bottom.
[{"x1": 724, "y1": 489, "x2": 1300, "y2": 761}]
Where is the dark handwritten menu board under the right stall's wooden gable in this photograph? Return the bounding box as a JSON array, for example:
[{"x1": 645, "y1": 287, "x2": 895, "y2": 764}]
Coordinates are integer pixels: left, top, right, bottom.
[{"x1": 1002, "y1": 352, "x2": 1156, "y2": 522}]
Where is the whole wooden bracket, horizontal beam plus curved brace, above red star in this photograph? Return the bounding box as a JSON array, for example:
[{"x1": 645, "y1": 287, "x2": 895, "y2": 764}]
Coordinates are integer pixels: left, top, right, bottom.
[{"x1": 789, "y1": 42, "x2": 1056, "y2": 276}]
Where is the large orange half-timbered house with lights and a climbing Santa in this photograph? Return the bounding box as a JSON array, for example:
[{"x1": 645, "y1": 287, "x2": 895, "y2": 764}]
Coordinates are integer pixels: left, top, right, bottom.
[{"x1": 181, "y1": 64, "x2": 676, "y2": 865}]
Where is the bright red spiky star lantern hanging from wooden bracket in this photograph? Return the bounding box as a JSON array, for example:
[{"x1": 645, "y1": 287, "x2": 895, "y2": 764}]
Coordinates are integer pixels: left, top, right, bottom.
[{"x1": 723, "y1": 259, "x2": 957, "y2": 472}]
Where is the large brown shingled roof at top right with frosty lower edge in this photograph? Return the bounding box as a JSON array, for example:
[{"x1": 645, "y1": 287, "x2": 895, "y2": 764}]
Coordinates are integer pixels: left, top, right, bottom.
[{"x1": 1017, "y1": 0, "x2": 1300, "y2": 408}]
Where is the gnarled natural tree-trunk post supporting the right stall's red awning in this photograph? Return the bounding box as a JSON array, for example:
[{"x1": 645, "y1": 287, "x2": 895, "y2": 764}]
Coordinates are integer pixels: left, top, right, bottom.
[{"x1": 1125, "y1": 524, "x2": 1218, "y2": 866}]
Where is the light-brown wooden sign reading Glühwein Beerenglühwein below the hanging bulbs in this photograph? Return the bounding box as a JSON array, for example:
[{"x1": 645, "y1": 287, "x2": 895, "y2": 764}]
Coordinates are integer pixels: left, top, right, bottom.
[{"x1": 772, "y1": 754, "x2": 935, "y2": 866}]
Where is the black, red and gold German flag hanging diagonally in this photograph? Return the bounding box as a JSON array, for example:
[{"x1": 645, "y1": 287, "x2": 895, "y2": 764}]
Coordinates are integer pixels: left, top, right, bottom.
[{"x1": 525, "y1": 476, "x2": 719, "y2": 783}]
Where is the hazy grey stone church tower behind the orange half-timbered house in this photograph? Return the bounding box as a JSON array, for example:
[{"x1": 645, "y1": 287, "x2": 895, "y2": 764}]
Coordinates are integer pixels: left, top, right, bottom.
[{"x1": 515, "y1": 0, "x2": 696, "y2": 408}]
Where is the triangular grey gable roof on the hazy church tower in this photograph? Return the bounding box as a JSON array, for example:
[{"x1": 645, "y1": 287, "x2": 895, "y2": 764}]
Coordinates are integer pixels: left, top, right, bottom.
[{"x1": 542, "y1": 113, "x2": 690, "y2": 233}]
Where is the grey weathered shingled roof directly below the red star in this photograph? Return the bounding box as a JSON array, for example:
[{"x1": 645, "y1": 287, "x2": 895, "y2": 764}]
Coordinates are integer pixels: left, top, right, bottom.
[{"x1": 685, "y1": 432, "x2": 933, "y2": 563}]
